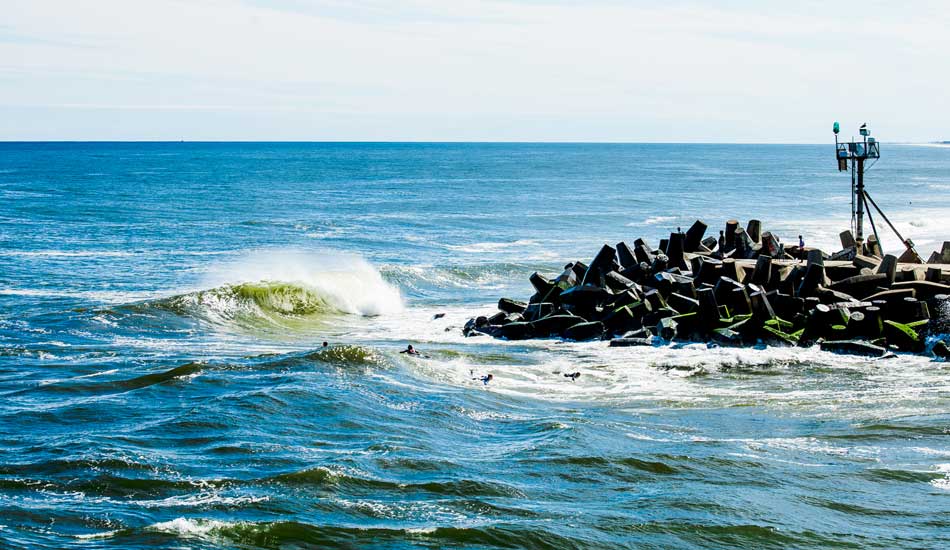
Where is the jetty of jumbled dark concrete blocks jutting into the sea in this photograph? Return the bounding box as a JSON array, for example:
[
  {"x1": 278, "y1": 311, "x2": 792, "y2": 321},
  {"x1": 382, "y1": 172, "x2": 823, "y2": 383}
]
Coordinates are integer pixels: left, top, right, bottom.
[{"x1": 463, "y1": 220, "x2": 950, "y2": 358}]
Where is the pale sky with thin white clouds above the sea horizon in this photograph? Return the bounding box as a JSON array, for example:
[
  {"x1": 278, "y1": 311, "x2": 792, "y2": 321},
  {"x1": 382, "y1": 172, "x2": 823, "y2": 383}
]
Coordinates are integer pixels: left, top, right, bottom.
[{"x1": 0, "y1": 0, "x2": 950, "y2": 143}]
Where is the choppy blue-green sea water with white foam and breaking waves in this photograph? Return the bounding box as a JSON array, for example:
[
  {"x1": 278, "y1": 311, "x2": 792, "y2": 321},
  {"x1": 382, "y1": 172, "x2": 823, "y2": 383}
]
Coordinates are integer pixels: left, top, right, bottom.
[{"x1": 0, "y1": 143, "x2": 950, "y2": 548}]
